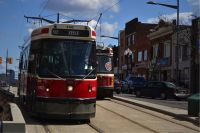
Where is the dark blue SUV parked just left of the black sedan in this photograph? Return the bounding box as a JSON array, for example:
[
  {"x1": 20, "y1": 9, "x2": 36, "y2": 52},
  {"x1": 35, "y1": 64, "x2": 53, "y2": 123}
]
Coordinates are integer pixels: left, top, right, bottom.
[{"x1": 124, "y1": 76, "x2": 146, "y2": 94}]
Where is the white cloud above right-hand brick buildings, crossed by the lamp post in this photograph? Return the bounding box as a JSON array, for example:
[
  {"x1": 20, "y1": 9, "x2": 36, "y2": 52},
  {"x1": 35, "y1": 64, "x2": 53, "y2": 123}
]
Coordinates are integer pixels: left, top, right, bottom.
[{"x1": 147, "y1": 12, "x2": 193, "y2": 24}]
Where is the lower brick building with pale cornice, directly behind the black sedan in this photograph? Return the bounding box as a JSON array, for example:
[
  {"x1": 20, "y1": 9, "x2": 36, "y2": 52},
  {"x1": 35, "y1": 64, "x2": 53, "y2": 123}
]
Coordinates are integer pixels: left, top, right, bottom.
[{"x1": 148, "y1": 21, "x2": 174, "y2": 81}]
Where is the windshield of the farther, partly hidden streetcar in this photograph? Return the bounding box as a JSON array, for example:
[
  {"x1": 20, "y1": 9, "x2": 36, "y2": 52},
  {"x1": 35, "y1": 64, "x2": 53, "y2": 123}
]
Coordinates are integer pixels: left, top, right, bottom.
[{"x1": 97, "y1": 55, "x2": 112, "y2": 73}]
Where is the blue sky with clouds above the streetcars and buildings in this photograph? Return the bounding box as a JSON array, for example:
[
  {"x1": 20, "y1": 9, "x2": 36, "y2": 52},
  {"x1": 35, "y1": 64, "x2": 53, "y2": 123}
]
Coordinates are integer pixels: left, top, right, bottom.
[{"x1": 0, "y1": 0, "x2": 200, "y2": 73}]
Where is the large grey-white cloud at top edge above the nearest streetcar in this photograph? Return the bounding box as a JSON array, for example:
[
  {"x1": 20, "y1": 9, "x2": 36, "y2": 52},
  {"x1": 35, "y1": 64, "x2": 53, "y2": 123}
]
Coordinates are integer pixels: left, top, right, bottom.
[{"x1": 43, "y1": 0, "x2": 119, "y2": 18}]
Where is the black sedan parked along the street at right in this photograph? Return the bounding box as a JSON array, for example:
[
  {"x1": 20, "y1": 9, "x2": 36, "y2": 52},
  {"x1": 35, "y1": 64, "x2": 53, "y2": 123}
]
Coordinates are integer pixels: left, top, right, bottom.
[{"x1": 134, "y1": 81, "x2": 190, "y2": 100}]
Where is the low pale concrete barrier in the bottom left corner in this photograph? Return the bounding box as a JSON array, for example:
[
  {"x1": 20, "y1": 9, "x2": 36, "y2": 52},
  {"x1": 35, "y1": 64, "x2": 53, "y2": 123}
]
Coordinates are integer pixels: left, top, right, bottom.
[{"x1": 2, "y1": 103, "x2": 25, "y2": 133}]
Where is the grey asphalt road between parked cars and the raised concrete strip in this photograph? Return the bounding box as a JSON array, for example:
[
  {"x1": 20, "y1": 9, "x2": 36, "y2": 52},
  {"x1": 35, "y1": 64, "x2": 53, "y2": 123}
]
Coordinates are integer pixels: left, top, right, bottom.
[{"x1": 114, "y1": 93, "x2": 188, "y2": 110}]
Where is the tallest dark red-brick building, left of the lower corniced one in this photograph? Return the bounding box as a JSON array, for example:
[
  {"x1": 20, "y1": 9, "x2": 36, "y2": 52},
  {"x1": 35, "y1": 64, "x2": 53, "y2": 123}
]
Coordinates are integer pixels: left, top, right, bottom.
[{"x1": 123, "y1": 18, "x2": 157, "y2": 79}]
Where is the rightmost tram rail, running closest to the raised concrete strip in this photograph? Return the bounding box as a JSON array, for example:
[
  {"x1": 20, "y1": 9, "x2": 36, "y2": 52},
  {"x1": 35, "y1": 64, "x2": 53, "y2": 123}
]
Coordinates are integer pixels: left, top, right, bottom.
[{"x1": 107, "y1": 99, "x2": 200, "y2": 132}]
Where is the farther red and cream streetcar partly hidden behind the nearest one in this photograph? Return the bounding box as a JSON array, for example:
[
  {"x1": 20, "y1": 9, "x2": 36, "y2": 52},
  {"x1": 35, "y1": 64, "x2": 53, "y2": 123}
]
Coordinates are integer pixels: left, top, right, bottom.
[{"x1": 96, "y1": 45, "x2": 114, "y2": 99}]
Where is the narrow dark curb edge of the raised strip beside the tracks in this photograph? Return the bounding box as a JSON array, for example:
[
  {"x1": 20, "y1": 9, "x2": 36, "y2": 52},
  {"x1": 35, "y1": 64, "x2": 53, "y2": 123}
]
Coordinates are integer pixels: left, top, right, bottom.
[{"x1": 112, "y1": 96, "x2": 200, "y2": 125}]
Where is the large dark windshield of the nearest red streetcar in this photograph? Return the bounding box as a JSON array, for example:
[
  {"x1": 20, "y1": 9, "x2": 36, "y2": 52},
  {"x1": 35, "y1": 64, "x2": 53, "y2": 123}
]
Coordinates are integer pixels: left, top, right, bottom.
[{"x1": 31, "y1": 39, "x2": 96, "y2": 78}]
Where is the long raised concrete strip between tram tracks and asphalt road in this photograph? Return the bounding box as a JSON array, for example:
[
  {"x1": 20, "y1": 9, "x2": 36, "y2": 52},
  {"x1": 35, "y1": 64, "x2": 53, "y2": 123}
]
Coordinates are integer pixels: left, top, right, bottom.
[{"x1": 113, "y1": 96, "x2": 200, "y2": 125}]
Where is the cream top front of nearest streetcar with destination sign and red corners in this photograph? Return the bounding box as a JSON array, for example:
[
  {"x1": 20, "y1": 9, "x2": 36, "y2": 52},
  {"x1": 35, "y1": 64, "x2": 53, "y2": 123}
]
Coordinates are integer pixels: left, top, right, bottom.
[{"x1": 28, "y1": 23, "x2": 96, "y2": 40}]
